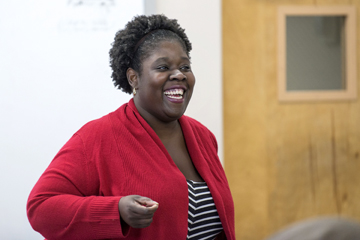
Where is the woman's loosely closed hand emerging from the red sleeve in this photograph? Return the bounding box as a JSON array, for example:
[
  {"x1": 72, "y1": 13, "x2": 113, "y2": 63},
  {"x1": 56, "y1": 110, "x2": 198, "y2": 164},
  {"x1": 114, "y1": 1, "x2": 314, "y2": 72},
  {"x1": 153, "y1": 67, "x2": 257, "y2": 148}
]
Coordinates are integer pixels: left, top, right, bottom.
[{"x1": 119, "y1": 195, "x2": 159, "y2": 228}]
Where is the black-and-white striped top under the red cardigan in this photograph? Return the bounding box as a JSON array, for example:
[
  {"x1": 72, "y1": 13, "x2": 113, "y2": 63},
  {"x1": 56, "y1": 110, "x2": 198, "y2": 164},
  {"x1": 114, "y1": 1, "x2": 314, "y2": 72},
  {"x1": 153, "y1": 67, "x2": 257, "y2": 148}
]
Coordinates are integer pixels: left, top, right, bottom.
[{"x1": 186, "y1": 180, "x2": 223, "y2": 240}]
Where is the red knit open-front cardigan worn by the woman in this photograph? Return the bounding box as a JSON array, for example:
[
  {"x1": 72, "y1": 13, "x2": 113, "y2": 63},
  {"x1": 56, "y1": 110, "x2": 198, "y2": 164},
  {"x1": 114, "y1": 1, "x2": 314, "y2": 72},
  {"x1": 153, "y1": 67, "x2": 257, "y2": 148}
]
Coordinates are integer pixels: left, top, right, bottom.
[{"x1": 27, "y1": 100, "x2": 235, "y2": 240}]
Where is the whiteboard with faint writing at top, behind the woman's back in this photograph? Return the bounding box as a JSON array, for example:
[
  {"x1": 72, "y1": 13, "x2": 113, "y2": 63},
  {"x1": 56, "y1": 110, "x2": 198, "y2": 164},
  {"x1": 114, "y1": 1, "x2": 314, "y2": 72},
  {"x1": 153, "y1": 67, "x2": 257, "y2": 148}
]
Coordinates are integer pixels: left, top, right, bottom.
[{"x1": 0, "y1": 0, "x2": 144, "y2": 240}]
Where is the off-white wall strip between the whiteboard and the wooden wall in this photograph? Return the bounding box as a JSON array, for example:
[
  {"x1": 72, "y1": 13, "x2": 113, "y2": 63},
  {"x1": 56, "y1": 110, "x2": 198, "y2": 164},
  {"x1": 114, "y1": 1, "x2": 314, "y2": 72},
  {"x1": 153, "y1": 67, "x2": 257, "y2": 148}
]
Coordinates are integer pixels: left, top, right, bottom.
[{"x1": 145, "y1": 0, "x2": 224, "y2": 163}]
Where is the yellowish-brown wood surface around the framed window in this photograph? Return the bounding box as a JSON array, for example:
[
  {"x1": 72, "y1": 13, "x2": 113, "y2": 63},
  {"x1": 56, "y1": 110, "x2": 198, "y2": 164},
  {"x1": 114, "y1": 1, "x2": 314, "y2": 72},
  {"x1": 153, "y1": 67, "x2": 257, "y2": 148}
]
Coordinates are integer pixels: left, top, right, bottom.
[{"x1": 222, "y1": 0, "x2": 360, "y2": 240}]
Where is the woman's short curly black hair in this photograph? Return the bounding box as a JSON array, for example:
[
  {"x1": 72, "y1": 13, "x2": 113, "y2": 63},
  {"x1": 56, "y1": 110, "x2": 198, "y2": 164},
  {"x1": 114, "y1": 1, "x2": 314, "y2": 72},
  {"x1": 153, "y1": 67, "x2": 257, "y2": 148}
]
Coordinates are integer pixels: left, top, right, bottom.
[{"x1": 109, "y1": 14, "x2": 192, "y2": 94}]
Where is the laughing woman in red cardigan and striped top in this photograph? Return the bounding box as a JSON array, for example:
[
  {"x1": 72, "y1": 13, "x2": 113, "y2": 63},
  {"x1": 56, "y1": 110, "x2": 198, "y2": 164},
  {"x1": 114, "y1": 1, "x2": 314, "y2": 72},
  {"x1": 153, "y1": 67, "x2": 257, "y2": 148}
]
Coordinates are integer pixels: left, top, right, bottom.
[{"x1": 27, "y1": 15, "x2": 235, "y2": 240}]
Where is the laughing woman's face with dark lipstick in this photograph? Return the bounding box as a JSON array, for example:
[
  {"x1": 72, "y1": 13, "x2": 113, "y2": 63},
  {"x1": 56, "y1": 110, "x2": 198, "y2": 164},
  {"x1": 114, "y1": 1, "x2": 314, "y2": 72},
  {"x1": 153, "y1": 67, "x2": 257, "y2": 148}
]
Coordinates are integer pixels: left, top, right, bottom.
[{"x1": 134, "y1": 40, "x2": 195, "y2": 122}]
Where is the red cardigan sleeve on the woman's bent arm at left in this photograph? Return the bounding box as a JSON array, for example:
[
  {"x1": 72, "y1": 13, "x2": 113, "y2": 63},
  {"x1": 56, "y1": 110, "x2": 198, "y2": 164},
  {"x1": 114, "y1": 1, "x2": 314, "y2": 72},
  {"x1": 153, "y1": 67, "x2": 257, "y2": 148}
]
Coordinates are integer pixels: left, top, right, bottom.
[{"x1": 27, "y1": 134, "x2": 129, "y2": 240}]
